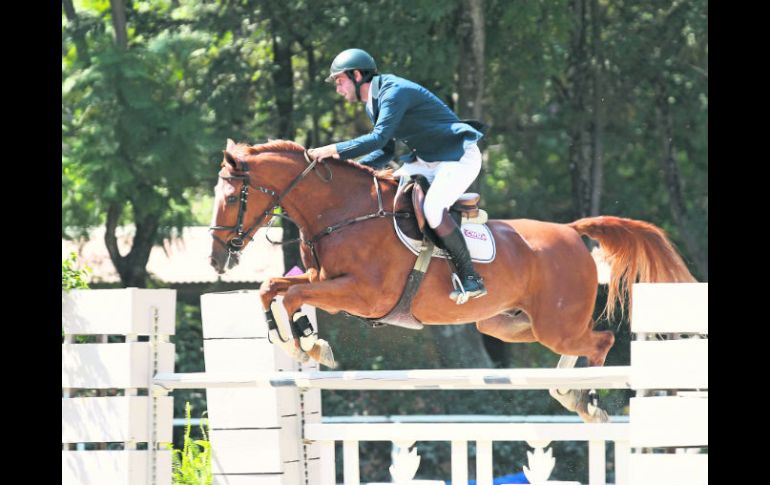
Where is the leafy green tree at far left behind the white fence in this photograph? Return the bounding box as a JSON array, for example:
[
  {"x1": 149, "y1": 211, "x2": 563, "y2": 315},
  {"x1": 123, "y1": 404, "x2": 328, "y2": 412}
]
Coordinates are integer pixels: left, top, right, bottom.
[{"x1": 62, "y1": 1, "x2": 218, "y2": 287}]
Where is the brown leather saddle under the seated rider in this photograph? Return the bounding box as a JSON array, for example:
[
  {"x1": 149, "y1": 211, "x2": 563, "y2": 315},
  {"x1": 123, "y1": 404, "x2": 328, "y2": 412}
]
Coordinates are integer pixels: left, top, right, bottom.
[{"x1": 394, "y1": 175, "x2": 487, "y2": 249}]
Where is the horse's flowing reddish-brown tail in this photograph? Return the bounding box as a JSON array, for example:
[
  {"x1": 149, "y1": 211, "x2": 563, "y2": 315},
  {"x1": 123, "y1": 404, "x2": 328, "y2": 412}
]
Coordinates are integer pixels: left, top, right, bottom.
[{"x1": 568, "y1": 216, "x2": 695, "y2": 317}]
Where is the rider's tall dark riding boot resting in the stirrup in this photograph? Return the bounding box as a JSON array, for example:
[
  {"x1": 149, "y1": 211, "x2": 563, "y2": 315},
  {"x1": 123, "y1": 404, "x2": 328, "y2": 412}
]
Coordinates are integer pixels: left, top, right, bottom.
[{"x1": 433, "y1": 211, "x2": 487, "y2": 305}]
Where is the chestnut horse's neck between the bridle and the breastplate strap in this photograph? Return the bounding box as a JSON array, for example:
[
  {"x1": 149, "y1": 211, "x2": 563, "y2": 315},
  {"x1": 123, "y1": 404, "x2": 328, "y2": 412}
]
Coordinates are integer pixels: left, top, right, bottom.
[{"x1": 272, "y1": 155, "x2": 388, "y2": 237}]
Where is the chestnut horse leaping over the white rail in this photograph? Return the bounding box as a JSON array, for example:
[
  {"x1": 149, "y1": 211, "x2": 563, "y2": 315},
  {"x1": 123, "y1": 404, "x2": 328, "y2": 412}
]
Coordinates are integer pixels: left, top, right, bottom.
[{"x1": 210, "y1": 140, "x2": 694, "y2": 421}]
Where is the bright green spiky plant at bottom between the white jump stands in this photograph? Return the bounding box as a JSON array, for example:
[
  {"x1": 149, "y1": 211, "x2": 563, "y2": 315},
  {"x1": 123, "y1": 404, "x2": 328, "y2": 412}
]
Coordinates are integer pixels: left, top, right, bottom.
[{"x1": 169, "y1": 402, "x2": 213, "y2": 485}]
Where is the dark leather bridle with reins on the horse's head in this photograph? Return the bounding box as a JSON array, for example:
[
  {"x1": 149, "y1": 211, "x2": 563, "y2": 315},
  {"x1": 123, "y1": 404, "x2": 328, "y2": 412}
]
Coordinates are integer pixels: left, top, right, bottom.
[{"x1": 209, "y1": 151, "x2": 324, "y2": 262}]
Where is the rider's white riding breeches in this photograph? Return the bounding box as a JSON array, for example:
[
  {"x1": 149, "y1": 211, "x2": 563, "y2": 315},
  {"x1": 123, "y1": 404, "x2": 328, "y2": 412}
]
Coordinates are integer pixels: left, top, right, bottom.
[{"x1": 393, "y1": 143, "x2": 481, "y2": 228}]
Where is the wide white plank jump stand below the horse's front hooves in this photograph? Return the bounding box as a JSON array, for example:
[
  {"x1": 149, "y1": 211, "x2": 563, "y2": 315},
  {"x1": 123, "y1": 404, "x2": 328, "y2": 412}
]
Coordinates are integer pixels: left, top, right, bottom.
[{"x1": 201, "y1": 290, "x2": 318, "y2": 485}]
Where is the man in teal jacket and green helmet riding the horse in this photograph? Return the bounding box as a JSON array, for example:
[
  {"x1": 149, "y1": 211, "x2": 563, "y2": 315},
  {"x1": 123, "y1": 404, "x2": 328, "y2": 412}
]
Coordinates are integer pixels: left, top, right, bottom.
[{"x1": 308, "y1": 49, "x2": 487, "y2": 303}]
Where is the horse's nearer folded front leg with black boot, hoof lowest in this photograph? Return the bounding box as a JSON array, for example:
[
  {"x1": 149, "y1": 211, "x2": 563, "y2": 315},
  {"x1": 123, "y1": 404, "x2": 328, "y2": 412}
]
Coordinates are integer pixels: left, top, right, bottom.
[{"x1": 283, "y1": 275, "x2": 368, "y2": 369}]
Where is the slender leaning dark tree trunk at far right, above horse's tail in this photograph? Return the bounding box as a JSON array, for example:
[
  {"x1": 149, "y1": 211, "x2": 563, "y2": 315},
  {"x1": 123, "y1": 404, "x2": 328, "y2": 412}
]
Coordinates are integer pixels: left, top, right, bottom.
[{"x1": 655, "y1": 87, "x2": 708, "y2": 281}]
